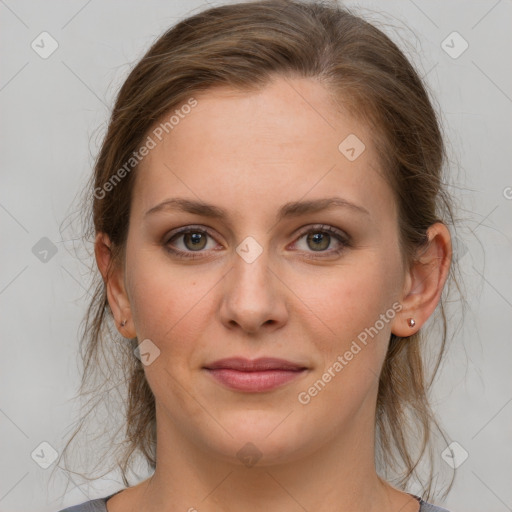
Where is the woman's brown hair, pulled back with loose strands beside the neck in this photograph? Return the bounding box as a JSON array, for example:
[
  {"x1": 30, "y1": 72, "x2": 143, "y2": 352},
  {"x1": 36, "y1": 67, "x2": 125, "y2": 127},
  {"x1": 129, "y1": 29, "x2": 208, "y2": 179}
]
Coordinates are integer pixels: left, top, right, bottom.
[{"x1": 55, "y1": 0, "x2": 459, "y2": 500}]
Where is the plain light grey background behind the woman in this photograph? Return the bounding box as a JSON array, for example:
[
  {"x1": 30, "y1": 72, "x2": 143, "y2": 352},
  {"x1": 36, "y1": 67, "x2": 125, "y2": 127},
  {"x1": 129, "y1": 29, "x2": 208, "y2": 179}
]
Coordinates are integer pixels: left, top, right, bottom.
[{"x1": 0, "y1": 0, "x2": 512, "y2": 512}]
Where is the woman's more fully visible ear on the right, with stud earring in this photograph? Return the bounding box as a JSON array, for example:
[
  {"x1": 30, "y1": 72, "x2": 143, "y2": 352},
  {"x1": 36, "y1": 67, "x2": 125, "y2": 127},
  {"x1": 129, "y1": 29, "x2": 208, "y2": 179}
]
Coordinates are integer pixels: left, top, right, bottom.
[{"x1": 391, "y1": 222, "x2": 452, "y2": 337}]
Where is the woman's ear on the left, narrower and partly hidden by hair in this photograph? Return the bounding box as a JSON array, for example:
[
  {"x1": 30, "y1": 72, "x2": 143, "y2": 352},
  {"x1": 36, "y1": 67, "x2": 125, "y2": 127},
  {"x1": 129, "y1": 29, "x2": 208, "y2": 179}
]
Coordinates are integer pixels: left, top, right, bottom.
[{"x1": 94, "y1": 233, "x2": 137, "y2": 338}]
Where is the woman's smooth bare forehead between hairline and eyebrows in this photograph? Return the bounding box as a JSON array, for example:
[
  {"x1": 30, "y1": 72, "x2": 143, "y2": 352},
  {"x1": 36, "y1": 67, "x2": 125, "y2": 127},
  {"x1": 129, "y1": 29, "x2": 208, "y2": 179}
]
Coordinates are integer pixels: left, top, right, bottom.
[{"x1": 132, "y1": 75, "x2": 391, "y2": 222}]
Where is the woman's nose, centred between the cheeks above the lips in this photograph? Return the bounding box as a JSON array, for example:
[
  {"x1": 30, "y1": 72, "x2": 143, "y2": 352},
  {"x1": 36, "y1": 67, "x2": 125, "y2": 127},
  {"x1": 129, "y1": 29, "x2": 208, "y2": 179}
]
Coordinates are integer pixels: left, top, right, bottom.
[{"x1": 220, "y1": 244, "x2": 288, "y2": 334}]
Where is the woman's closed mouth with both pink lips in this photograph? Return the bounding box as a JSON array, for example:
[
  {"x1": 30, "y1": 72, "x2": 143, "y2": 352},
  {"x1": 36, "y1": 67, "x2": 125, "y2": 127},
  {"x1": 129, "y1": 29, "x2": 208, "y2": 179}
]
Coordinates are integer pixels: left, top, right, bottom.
[{"x1": 203, "y1": 357, "x2": 308, "y2": 393}]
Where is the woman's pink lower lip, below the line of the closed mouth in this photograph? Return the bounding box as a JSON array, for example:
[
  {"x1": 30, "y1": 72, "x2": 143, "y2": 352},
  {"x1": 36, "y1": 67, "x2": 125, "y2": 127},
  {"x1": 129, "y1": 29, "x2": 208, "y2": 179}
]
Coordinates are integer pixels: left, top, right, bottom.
[{"x1": 207, "y1": 368, "x2": 306, "y2": 392}]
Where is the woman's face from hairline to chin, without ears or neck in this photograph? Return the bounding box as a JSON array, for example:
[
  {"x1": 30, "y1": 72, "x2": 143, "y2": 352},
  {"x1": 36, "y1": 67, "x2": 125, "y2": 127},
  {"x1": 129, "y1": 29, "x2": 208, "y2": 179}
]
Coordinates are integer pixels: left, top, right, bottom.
[{"x1": 116, "y1": 79, "x2": 404, "y2": 464}]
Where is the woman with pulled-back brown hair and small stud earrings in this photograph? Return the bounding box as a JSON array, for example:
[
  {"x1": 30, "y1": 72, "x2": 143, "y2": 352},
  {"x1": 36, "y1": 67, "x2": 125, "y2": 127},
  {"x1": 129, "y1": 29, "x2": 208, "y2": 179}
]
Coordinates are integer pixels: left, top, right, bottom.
[{"x1": 54, "y1": 0, "x2": 453, "y2": 512}]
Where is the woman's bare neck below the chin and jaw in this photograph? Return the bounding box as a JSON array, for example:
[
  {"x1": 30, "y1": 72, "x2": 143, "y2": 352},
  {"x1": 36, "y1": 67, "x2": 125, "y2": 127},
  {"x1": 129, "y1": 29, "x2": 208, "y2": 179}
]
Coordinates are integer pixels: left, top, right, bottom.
[{"x1": 133, "y1": 405, "x2": 412, "y2": 512}]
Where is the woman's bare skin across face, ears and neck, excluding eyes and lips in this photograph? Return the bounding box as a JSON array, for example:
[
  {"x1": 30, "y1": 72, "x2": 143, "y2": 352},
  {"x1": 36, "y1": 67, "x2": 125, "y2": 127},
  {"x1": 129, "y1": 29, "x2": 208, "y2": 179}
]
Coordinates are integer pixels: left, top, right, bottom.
[{"x1": 95, "y1": 78, "x2": 451, "y2": 512}]
